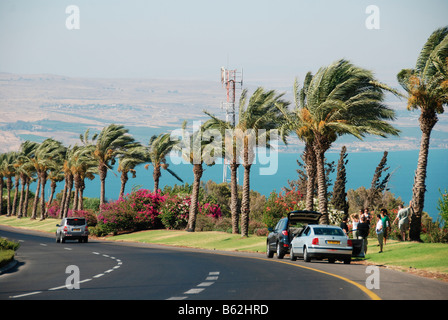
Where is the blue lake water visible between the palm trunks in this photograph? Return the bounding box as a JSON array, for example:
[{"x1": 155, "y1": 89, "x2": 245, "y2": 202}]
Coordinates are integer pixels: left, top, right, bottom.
[{"x1": 36, "y1": 149, "x2": 448, "y2": 219}]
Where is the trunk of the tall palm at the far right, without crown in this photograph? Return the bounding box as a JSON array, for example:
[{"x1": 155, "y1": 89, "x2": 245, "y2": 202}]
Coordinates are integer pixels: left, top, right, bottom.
[{"x1": 409, "y1": 111, "x2": 438, "y2": 241}]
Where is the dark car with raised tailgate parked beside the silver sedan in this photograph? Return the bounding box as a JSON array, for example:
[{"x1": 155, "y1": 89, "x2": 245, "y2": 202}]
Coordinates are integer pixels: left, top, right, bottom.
[{"x1": 266, "y1": 210, "x2": 322, "y2": 259}]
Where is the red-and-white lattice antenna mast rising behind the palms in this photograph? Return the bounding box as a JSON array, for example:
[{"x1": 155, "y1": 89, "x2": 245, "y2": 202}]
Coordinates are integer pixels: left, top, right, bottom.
[{"x1": 221, "y1": 67, "x2": 243, "y2": 182}]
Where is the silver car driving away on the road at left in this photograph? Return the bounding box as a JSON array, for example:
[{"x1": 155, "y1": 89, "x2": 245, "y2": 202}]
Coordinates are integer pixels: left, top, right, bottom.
[{"x1": 56, "y1": 217, "x2": 89, "y2": 243}]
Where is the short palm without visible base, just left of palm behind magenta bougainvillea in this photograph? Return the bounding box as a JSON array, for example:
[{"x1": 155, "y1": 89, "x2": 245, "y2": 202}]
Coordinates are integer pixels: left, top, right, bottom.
[{"x1": 118, "y1": 145, "x2": 147, "y2": 198}]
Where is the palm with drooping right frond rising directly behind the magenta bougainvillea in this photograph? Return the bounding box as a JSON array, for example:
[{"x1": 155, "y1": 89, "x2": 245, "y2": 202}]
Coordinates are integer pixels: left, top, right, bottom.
[{"x1": 145, "y1": 133, "x2": 183, "y2": 192}]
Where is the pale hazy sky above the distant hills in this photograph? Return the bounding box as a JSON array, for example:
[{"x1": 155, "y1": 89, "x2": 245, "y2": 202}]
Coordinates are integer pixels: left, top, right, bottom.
[{"x1": 0, "y1": 0, "x2": 448, "y2": 86}]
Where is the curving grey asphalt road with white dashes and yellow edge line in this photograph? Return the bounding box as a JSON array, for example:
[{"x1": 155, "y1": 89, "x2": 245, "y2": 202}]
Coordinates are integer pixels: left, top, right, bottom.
[{"x1": 0, "y1": 226, "x2": 448, "y2": 302}]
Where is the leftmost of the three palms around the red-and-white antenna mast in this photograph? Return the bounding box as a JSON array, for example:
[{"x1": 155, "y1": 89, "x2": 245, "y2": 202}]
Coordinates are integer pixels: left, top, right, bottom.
[{"x1": 178, "y1": 121, "x2": 221, "y2": 232}]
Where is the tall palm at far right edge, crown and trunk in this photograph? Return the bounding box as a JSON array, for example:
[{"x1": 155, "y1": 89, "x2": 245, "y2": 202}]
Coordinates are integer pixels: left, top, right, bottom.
[{"x1": 397, "y1": 27, "x2": 448, "y2": 241}]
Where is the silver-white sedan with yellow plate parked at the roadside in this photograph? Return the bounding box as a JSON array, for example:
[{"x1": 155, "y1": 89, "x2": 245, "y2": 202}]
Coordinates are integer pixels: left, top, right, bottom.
[{"x1": 290, "y1": 224, "x2": 353, "y2": 264}]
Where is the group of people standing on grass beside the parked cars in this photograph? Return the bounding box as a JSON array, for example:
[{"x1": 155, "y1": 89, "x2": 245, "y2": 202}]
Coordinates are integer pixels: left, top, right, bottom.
[{"x1": 341, "y1": 201, "x2": 412, "y2": 253}]
